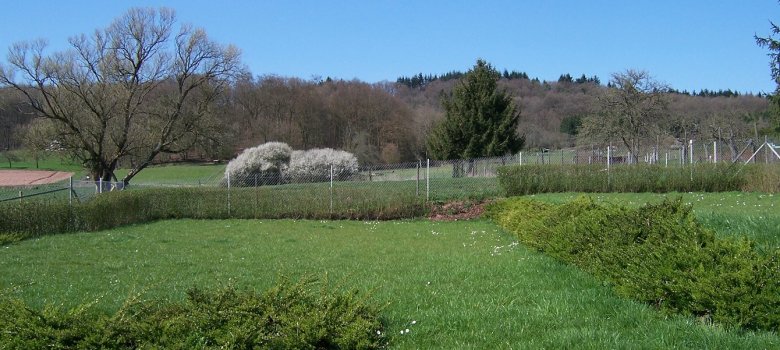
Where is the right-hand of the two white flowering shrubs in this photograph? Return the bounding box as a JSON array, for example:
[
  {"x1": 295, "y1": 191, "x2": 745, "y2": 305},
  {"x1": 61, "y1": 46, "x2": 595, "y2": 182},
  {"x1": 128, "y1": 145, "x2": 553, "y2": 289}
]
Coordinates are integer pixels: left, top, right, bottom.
[{"x1": 285, "y1": 148, "x2": 358, "y2": 182}]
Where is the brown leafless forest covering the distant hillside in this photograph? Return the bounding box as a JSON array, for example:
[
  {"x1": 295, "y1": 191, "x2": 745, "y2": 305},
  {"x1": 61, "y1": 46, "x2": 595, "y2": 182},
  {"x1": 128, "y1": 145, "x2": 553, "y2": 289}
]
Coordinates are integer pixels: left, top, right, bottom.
[{"x1": 0, "y1": 70, "x2": 773, "y2": 164}]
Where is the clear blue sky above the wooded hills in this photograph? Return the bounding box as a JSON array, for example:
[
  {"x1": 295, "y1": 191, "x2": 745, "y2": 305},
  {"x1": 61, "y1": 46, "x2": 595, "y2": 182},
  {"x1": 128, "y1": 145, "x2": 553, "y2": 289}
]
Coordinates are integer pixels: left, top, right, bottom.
[{"x1": 0, "y1": 0, "x2": 780, "y2": 93}]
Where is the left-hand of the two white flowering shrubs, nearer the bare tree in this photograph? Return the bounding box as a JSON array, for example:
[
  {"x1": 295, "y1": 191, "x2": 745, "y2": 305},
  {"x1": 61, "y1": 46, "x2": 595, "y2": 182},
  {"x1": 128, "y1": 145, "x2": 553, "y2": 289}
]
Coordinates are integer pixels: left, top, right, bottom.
[{"x1": 223, "y1": 142, "x2": 293, "y2": 186}]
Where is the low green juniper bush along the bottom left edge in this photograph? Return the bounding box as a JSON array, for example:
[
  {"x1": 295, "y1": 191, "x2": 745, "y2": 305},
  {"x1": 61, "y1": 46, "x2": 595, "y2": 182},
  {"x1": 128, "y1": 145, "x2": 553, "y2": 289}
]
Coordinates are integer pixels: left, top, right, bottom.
[{"x1": 0, "y1": 281, "x2": 385, "y2": 349}]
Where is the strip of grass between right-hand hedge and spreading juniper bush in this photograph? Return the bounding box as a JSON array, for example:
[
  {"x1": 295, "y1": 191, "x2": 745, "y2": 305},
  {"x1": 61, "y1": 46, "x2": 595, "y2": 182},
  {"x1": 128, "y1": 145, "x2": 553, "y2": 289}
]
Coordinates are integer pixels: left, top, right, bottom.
[{"x1": 528, "y1": 192, "x2": 780, "y2": 250}]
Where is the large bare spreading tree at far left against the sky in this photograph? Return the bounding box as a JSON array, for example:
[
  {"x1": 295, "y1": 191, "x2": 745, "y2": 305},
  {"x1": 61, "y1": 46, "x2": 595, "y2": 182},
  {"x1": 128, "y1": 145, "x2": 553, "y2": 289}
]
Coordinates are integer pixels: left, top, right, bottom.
[{"x1": 0, "y1": 8, "x2": 241, "y2": 183}]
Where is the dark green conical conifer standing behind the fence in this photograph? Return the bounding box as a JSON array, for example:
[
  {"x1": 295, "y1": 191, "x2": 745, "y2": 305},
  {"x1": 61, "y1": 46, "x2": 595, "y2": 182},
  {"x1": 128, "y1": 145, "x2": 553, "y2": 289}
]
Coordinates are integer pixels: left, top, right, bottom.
[{"x1": 428, "y1": 60, "x2": 524, "y2": 159}]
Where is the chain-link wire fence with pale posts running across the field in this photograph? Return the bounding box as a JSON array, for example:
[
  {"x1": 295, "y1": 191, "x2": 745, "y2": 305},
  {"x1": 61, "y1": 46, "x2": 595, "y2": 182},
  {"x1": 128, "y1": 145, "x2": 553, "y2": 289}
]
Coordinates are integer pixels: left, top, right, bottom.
[{"x1": 0, "y1": 140, "x2": 780, "y2": 206}]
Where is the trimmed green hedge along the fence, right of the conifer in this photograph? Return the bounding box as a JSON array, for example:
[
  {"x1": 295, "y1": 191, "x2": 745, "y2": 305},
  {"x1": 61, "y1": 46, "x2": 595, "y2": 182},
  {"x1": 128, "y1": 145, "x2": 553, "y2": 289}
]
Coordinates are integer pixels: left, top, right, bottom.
[{"x1": 498, "y1": 164, "x2": 748, "y2": 196}]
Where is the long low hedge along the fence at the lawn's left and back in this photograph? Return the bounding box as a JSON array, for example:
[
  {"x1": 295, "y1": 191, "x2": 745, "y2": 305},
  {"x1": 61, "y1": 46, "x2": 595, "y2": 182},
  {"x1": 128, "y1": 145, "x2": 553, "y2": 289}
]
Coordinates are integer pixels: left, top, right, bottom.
[{"x1": 0, "y1": 187, "x2": 427, "y2": 244}]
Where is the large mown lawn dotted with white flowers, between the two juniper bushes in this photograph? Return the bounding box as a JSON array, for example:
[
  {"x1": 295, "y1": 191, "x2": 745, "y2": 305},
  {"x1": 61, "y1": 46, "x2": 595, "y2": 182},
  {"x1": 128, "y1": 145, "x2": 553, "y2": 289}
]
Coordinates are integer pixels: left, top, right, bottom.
[{"x1": 0, "y1": 220, "x2": 780, "y2": 349}]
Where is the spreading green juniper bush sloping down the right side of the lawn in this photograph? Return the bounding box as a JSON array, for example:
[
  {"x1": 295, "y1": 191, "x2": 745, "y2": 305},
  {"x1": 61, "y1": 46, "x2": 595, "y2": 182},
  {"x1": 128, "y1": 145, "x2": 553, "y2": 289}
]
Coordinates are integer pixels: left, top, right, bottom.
[{"x1": 489, "y1": 197, "x2": 780, "y2": 331}]
